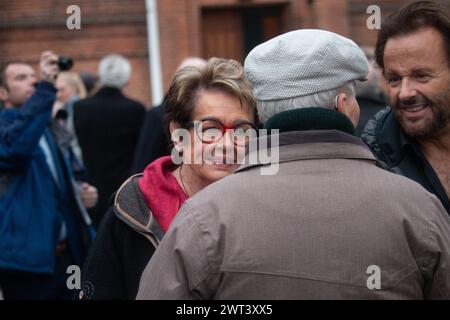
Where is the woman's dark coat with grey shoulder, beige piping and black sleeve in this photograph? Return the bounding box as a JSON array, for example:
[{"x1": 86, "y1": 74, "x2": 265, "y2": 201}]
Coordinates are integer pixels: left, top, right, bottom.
[{"x1": 79, "y1": 175, "x2": 163, "y2": 300}]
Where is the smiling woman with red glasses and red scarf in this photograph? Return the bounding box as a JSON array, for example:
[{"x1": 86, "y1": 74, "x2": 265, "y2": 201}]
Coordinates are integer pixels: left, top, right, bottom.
[{"x1": 79, "y1": 58, "x2": 258, "y2": 299}]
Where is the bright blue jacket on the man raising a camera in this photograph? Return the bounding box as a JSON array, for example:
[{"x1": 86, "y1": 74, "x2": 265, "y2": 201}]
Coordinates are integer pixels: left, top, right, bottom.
[{"x1": 0, "y1": 82, "x2": 89, "y2": 273}]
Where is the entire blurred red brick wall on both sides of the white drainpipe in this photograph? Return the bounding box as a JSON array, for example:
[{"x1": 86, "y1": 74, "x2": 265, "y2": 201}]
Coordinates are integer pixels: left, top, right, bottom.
[{"x1": 0, "y1": 0, "x2": 450, "y2": 107}]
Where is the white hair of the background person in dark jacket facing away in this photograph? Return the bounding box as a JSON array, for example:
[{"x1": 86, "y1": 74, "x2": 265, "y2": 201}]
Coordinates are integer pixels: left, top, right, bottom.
[{"x1": 98, "y1": 54, "x2": 131, "y2": 89}]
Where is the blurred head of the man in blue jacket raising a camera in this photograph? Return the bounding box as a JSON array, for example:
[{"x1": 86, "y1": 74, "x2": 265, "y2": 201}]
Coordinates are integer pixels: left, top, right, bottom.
[{"x1": 0, "y1": 63, "x2": 37, "y2": 108}]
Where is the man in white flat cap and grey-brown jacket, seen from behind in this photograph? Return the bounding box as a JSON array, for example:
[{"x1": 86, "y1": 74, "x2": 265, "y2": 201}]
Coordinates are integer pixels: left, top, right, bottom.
[{"x1": 137, "y1": 30, "x2": 450, "y2": 299}]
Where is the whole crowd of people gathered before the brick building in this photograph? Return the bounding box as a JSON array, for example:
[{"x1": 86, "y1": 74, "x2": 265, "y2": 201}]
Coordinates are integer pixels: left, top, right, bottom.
[{"x1": 0, "y1": 1, "x2": 450, "y2": 300}]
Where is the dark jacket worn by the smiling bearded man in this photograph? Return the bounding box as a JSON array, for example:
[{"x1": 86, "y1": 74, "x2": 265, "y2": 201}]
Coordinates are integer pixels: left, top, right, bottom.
[{"x1": 361, "y1": 108, "x2": 450, "y2": 214}]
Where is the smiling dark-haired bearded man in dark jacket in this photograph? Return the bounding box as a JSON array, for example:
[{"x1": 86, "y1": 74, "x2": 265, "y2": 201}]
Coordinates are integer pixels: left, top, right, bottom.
[{"x1": 361, "y1": 1, "x2": 450, "y2": 214}]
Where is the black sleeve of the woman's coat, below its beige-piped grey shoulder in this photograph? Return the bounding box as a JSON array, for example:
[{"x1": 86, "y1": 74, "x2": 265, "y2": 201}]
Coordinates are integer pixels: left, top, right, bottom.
[{"x1": 79, "y1": 208, "x2": 155, "y2": 300}]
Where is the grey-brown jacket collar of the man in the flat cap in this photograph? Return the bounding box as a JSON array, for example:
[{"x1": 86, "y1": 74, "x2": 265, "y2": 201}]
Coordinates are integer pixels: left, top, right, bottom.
[{"x1": 237, "y1": 130, "x2": 378, "y2": 172}]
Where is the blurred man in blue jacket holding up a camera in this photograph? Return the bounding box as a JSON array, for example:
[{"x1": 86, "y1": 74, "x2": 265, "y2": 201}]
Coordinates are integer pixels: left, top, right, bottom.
[{"x1": 0, "y1": 51, "x2": 96, "y2": 300}]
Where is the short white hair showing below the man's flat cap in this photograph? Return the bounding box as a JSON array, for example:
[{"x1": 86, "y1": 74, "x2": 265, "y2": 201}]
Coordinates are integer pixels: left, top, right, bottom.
[{"x1": 256, "y1": 81, "x2": 355, "y2": 123}]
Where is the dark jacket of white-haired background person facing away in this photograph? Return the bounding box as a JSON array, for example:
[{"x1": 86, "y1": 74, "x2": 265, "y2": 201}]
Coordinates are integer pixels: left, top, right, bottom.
[{"x1": 74, "y1": 88, "x2": 145, "y2": 225}]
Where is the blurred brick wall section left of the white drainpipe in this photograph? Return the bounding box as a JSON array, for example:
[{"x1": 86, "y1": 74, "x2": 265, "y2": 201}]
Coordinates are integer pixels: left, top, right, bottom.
[{"x1": 0, "y1": 0, "x2": 151, "y2": 106}]
